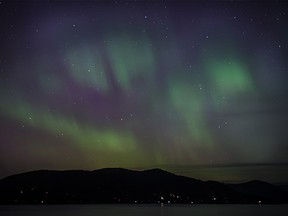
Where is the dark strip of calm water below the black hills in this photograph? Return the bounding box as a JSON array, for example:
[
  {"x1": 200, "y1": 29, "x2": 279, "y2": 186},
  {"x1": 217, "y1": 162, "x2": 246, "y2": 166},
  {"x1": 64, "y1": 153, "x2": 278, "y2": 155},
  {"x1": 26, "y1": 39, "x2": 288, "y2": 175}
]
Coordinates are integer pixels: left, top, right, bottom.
[{"x1": 0, "y1": 205, "x2": 288, "y2": 216}]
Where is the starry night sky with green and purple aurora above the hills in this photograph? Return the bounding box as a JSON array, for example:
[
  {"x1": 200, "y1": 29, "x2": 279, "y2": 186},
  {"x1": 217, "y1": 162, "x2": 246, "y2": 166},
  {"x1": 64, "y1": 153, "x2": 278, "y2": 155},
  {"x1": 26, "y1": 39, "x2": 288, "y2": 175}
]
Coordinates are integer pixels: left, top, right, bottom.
[{"x1": 0, "y1": 1, "x2": 288, "y2": 182}]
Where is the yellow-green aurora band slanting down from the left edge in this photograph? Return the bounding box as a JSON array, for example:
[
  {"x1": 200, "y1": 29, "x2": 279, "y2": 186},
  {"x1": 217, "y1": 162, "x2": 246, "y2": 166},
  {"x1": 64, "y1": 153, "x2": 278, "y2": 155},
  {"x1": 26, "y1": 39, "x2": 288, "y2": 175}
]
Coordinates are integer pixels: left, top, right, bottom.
[{"x1": 1, "y1": 102, "x2": 136, "y2": 152}]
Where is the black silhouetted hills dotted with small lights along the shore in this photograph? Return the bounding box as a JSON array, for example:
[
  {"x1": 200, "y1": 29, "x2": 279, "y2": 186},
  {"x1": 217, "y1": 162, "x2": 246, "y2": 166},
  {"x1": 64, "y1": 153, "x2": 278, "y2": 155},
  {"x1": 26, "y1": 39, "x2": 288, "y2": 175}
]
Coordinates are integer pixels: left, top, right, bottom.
[{"x1": 0, "y1": 168, "x2": 288, "y2": 204}]
